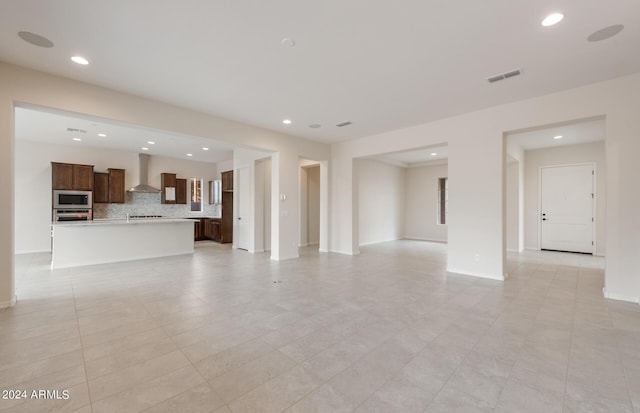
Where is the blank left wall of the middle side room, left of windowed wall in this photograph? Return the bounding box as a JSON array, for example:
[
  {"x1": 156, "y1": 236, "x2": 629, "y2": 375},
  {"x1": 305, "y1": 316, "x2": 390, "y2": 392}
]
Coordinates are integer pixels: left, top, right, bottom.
[{"x1": 357, "y1": 159, "x2": 405, "y2": 245}]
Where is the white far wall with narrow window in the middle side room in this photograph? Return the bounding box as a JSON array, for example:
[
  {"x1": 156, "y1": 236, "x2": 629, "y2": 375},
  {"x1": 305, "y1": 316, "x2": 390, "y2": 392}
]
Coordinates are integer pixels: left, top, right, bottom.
[{"x1": 404, "y1": 164, "x2": 451, "y2": 242}]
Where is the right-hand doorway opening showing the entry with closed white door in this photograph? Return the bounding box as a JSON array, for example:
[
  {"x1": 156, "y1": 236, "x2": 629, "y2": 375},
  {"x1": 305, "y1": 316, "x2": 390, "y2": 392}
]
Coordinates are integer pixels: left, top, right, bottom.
[{"x1": 504, "y1": 116, "x2": 606, "y2": 256}]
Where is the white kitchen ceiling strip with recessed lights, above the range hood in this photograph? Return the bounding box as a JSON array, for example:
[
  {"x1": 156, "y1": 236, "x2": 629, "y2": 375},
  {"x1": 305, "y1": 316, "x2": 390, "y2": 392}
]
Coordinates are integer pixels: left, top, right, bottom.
[{"x1": 15, "y1": 108, "x2": 233, "y2": 163}]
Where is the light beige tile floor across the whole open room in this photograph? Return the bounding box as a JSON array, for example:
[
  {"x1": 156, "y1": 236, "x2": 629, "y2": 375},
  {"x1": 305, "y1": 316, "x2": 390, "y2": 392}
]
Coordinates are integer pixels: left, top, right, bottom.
[{"x1": 0, "y1": 241, "x2": 640, "y2": 413}]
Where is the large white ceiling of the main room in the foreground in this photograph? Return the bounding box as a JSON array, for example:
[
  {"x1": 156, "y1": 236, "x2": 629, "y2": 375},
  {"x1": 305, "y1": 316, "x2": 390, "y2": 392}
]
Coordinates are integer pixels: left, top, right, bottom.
[{"x1": 0, "y1": 0, "x2": 640, "y2": 142}]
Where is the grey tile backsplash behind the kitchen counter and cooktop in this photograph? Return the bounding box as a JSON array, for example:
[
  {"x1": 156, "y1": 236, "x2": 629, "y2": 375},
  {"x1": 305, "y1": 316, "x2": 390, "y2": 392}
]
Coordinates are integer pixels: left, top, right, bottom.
[{"x1": 93, "y1": 192, "x2": 220, "y2": 219}]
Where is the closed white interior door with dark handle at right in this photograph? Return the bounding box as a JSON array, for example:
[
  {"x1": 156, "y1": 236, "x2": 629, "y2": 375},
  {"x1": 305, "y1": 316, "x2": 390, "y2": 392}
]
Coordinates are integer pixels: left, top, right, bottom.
[{"x1": 540, "y1": 164, "x2": 594, "y2": 254}]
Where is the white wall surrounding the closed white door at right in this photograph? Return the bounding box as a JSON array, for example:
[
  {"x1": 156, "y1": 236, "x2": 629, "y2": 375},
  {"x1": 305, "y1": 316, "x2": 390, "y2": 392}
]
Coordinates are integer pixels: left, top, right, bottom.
[{"x1": 525, "y1": 142, "x2": 607, "y2": 255}]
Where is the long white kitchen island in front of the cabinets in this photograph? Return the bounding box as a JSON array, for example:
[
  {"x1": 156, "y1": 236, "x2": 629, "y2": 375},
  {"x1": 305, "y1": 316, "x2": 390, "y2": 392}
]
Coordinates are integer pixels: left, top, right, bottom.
[{"x1": 51, "y1": 218, "x2": 194, "y2": 268}]
